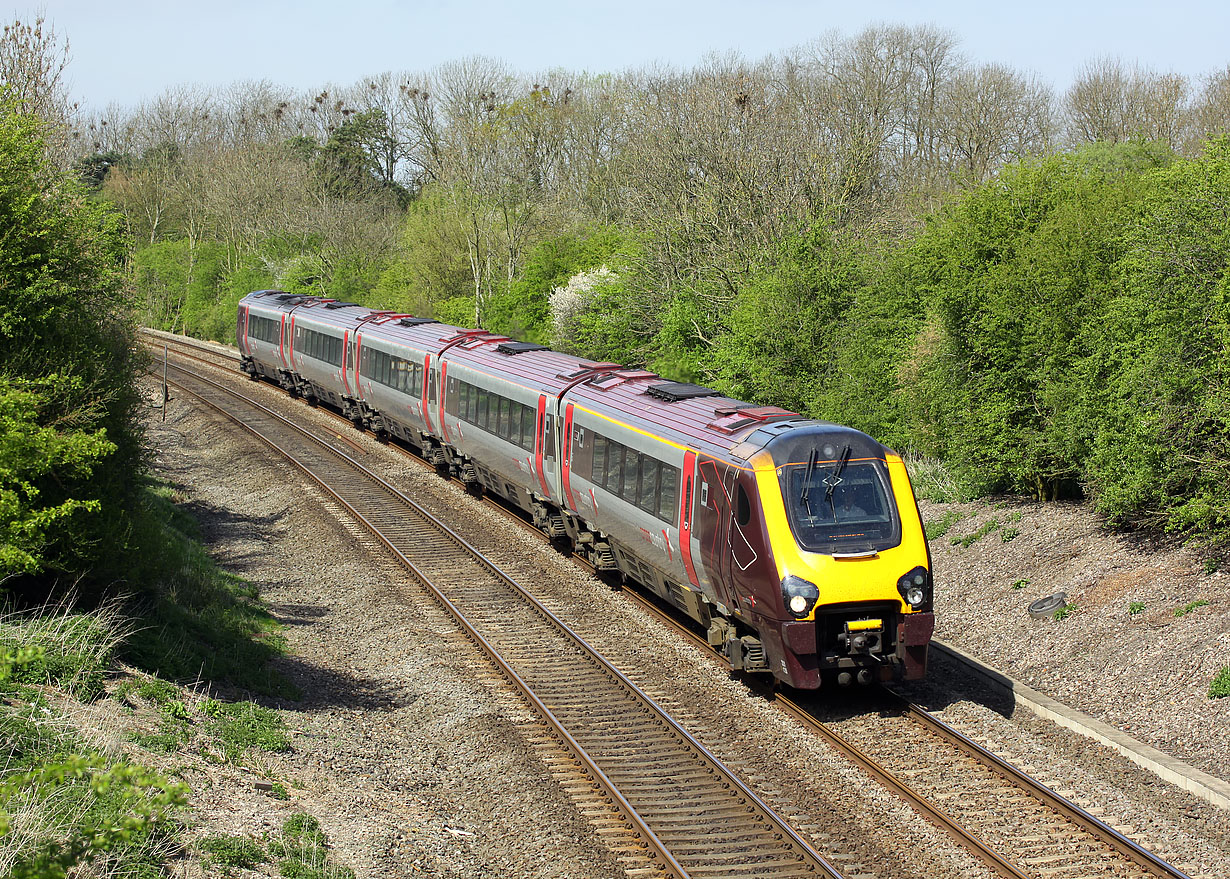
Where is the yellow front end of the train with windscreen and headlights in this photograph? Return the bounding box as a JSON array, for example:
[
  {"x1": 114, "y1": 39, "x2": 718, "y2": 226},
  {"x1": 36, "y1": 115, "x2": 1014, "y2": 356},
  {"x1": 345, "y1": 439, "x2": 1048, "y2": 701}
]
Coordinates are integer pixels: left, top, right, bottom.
[{"x1": 752, "y1": 424, "x2": 935, "y2": 688}]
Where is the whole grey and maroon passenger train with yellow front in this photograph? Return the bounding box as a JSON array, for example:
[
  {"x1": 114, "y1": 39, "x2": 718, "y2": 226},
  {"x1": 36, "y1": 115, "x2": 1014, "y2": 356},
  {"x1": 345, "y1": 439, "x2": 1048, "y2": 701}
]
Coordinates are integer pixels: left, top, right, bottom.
[{"x1": 236, "y1": 290, "x2": 935, "y2": 690}]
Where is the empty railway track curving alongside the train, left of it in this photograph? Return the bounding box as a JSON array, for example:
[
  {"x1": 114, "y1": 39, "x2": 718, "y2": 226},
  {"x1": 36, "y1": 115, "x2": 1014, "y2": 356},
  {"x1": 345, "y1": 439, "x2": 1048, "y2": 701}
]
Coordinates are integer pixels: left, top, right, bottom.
[{"x1": 153, "y1": 356, "x2": 841, "y2": 879}]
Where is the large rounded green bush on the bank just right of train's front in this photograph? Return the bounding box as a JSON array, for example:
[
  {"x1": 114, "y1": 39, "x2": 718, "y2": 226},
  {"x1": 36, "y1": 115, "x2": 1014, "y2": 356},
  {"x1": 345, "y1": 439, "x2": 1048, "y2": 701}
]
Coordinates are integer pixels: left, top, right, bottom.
[{"x1": 895, "y1": 146, "x2": 1156, "y2": 498}]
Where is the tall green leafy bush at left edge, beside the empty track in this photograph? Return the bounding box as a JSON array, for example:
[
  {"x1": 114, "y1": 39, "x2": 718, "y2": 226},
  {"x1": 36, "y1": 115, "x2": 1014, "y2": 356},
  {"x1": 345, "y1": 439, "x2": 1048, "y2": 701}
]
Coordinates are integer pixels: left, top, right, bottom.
[{"x1": 0, "y1": 103, "x2": 139, "y2": 593}]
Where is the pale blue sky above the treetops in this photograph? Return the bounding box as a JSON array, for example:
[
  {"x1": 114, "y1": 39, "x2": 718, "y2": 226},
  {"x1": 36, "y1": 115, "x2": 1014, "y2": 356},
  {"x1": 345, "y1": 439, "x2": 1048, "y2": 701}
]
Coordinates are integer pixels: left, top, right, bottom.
[{"x1": 14, "y1": 0, "x2": 1230, "y2": 111}]
